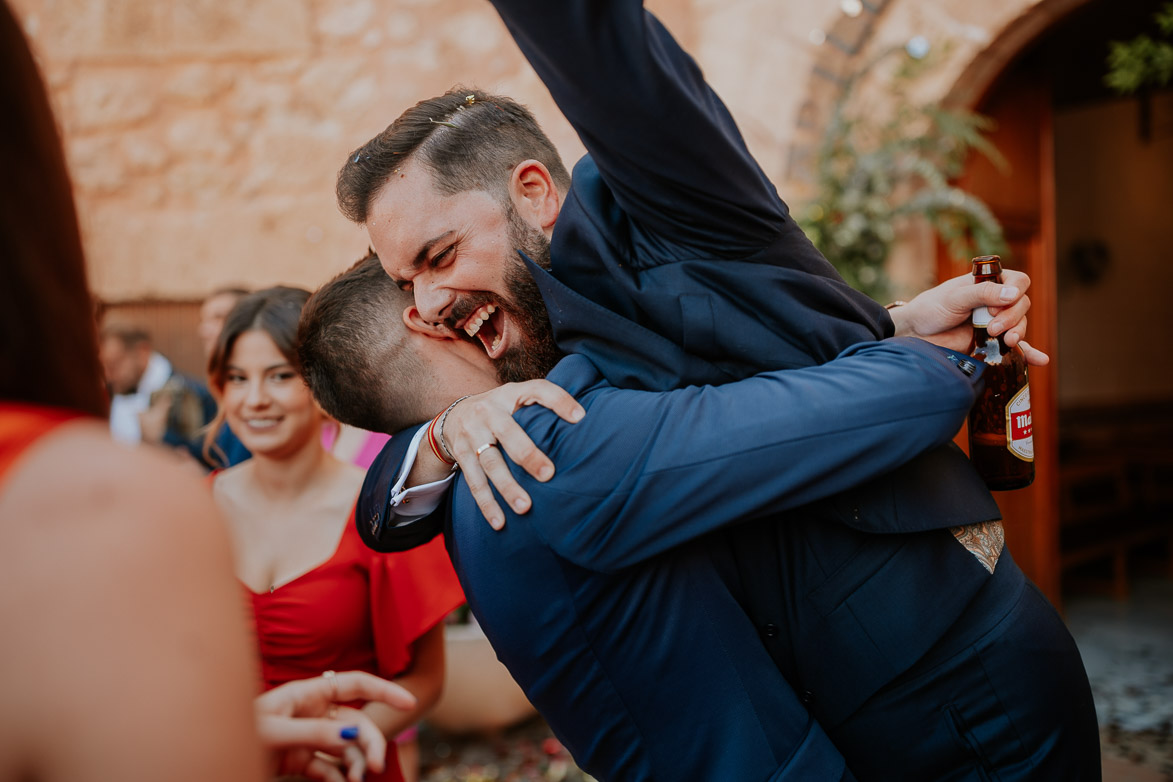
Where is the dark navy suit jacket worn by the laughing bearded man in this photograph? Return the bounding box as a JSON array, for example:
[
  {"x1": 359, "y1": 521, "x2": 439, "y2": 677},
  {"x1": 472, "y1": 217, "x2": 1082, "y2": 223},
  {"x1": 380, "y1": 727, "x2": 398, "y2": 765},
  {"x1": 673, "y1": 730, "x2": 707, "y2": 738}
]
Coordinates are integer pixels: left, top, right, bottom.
[{"x1": 495, "y1": 0, "x2": 1022, "y2": 727}]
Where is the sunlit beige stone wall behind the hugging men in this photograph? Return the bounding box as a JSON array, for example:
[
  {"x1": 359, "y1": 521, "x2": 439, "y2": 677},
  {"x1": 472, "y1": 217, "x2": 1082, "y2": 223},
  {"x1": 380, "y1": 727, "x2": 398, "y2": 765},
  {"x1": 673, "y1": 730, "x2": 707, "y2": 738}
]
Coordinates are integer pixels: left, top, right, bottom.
[{"x1": 9, "y1": 0, "x2": 1051, "y2": 300}]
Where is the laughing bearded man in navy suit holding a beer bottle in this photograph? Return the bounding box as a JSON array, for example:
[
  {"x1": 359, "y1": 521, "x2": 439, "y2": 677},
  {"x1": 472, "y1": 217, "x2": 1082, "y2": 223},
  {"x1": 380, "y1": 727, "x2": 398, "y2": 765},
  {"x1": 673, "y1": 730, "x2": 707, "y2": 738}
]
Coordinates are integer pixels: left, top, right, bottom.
[{"x1": 312, "y1": 0, "x2": 1098, "y2": 778}]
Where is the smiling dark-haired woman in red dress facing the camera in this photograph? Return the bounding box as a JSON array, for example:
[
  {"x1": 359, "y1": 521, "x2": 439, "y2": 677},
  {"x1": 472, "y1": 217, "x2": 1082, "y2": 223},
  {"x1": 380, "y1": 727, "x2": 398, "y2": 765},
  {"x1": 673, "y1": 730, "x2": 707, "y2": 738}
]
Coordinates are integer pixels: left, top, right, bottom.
[{"x1": 208, "y1": 287, "x2": 463, "y2": 780}]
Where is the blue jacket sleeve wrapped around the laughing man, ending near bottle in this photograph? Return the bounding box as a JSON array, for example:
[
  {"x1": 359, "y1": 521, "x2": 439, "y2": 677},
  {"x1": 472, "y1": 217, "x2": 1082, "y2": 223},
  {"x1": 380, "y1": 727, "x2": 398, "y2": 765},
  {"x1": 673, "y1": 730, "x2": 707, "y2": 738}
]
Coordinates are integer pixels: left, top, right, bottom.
[{"x1": 518, "y1": 338, "x2": 981, "y2": 571}]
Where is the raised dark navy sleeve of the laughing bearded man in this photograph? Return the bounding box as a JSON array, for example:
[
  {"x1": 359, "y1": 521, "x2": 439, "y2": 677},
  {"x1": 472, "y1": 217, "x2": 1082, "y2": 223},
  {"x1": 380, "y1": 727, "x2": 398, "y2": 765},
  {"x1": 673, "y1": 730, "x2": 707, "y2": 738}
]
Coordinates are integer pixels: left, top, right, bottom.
[{"x1": 494, "y1": 0, "x2": 788, "y2": 256}]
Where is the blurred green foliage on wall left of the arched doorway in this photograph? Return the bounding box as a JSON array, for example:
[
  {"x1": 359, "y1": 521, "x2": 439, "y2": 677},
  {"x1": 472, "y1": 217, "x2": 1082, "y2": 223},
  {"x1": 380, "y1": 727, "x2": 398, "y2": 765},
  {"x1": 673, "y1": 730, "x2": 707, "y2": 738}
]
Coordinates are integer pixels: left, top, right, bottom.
[{"x1": 799, "y1": 42, "x2": 1006, "y2": 301}]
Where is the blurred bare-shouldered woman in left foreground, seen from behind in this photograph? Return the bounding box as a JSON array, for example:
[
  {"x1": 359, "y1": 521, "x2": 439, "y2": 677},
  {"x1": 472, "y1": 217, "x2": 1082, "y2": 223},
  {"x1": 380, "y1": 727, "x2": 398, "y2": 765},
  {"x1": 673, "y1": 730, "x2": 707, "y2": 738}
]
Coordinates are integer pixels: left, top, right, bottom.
[{"x1": 0, "y1": 2, "x2": 414, "y2": 782}]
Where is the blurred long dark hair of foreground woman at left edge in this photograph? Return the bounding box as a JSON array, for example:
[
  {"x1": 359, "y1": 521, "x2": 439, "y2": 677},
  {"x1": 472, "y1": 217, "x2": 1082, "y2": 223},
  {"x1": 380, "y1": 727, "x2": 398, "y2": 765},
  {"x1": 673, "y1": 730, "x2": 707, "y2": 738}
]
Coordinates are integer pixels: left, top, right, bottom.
[{"x1": 0, "y1": 0, "x2": 109, "y2": 417}]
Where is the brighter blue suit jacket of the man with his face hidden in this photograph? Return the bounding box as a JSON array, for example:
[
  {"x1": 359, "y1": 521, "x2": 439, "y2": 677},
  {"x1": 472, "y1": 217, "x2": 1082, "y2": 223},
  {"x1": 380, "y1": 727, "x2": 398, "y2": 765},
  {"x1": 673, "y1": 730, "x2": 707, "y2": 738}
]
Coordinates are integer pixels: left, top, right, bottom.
[{"x1": 358, "y1": 340, "x2": 978, "y2": 782}]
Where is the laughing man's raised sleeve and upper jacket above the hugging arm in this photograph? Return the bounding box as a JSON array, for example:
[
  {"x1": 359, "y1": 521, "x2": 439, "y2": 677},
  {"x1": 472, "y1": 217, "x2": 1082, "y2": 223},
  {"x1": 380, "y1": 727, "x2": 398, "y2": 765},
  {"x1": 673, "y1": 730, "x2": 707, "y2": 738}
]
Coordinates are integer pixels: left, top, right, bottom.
[{"x1": 495, "y1": 0, "x2": 893, "y2": 390}]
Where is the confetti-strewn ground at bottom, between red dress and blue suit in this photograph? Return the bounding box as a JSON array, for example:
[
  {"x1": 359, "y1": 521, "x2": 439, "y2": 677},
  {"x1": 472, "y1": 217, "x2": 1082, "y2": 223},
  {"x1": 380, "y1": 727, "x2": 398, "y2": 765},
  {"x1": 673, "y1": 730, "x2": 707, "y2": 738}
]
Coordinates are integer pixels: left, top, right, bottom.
[{"x1": 420, "y1": 719, "x2": 594, "y2": 782}]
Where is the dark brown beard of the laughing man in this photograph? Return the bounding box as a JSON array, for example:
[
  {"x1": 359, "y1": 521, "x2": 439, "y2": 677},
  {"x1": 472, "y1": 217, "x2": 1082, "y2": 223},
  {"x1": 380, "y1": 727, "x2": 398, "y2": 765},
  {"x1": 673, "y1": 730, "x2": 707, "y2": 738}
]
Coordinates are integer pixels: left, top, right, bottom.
[{"x1": 493, "y1": 214, "x2": 563, "y2": 383}]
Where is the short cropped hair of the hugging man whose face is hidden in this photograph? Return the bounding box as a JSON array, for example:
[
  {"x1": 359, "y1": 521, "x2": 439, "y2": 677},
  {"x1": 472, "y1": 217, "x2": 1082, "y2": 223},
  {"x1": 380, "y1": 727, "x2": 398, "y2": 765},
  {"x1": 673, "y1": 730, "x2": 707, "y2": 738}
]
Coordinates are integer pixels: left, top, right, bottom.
[{"x1": 298, "y1": 251, "x2": 434, "y2": 434}]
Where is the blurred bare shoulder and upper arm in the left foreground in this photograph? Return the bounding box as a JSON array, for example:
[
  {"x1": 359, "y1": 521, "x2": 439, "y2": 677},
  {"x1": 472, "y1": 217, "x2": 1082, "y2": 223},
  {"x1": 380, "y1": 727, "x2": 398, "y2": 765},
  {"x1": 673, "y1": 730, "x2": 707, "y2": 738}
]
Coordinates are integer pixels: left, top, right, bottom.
[{"x1": 0, "y1": 421, "x2": 259, "y2": 778}]
